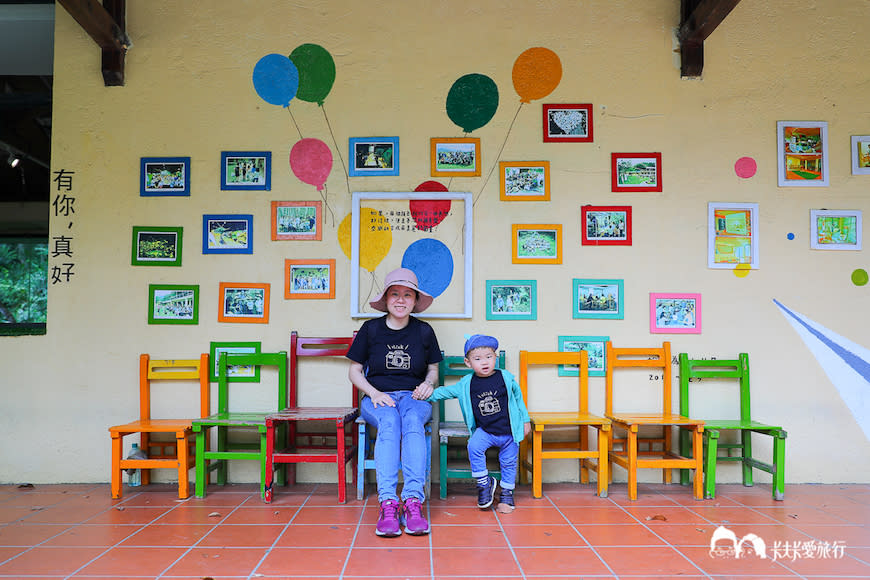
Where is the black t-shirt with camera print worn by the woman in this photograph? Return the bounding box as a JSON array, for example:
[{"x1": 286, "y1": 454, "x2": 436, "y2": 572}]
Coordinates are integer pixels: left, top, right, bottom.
[{"x1": 347, "y1": 315, "x2": 441, "y2": 392}]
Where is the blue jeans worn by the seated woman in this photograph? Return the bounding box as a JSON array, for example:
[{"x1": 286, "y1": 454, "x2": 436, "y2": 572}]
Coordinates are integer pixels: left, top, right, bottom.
[{"x1": 360, "y1": 391, "x2": 432, "y2": 502}]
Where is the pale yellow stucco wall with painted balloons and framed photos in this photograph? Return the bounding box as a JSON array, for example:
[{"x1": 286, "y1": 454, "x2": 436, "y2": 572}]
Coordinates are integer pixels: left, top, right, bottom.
[{"x1": 0, "y1": 0, "x2": 870, "y2": 483}]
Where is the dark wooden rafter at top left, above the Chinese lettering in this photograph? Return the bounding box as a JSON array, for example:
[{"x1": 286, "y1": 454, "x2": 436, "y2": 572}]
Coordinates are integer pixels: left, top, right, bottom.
[{"x1": 57, "y1": 0, "x2": 133, "y2": 87}]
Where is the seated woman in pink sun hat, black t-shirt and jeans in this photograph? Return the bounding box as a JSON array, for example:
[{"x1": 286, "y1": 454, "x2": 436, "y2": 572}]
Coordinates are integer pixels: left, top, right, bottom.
[{"x1": 347, "y1": 268, "x2": 441, "y2": 536}]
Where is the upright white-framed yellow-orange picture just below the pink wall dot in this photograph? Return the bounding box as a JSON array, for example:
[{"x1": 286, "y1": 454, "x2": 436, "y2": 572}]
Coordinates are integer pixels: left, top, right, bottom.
[{"x1": 707, "y1": 202, "x2": 758, "y2": 270}]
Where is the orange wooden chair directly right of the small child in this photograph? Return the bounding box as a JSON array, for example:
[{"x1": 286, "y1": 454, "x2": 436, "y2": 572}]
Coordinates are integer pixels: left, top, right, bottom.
[{"x1": 520, "y1": 350, "x2": 610, "y2": 498}]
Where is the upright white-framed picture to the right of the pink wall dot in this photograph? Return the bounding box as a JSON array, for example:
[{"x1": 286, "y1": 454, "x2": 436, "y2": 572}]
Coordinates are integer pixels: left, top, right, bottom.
[{"x1": 776, "y1": 121, "x2": 828, "y2": 187}]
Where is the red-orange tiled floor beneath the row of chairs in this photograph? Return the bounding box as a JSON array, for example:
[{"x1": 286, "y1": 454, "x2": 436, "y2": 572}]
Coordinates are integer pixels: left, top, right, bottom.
[{"x1": 0, "y1": 482, "x2": 870, "y2": 580}]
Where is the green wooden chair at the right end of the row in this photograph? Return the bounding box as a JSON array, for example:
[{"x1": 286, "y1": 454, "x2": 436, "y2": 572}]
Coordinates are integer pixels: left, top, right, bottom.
[{"x1": 680, "y1": 353, "x2": 787, "y2": 500}]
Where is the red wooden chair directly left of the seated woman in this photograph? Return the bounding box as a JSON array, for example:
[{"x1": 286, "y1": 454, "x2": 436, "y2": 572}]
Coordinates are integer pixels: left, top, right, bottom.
[{"x1": 264, "y1": 330, "x2": 359, "y2": 503}]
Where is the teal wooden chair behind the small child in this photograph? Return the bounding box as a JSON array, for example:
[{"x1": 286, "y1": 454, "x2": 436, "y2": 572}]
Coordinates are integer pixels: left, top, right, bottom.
[{"x1": 437, "y1": 350, "x2": 505, "y2": 499}]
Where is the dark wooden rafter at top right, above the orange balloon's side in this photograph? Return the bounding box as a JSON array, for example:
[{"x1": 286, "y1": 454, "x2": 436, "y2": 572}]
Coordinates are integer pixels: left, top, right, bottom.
[{"x1": 677, "y1": 0, "x2": 740, "y2": 77}]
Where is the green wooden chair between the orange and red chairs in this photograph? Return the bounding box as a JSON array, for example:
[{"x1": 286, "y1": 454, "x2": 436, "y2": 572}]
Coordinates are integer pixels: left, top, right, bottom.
[{"x1": 193, "y1": 351, "x2": 288, "y2": 498}]
